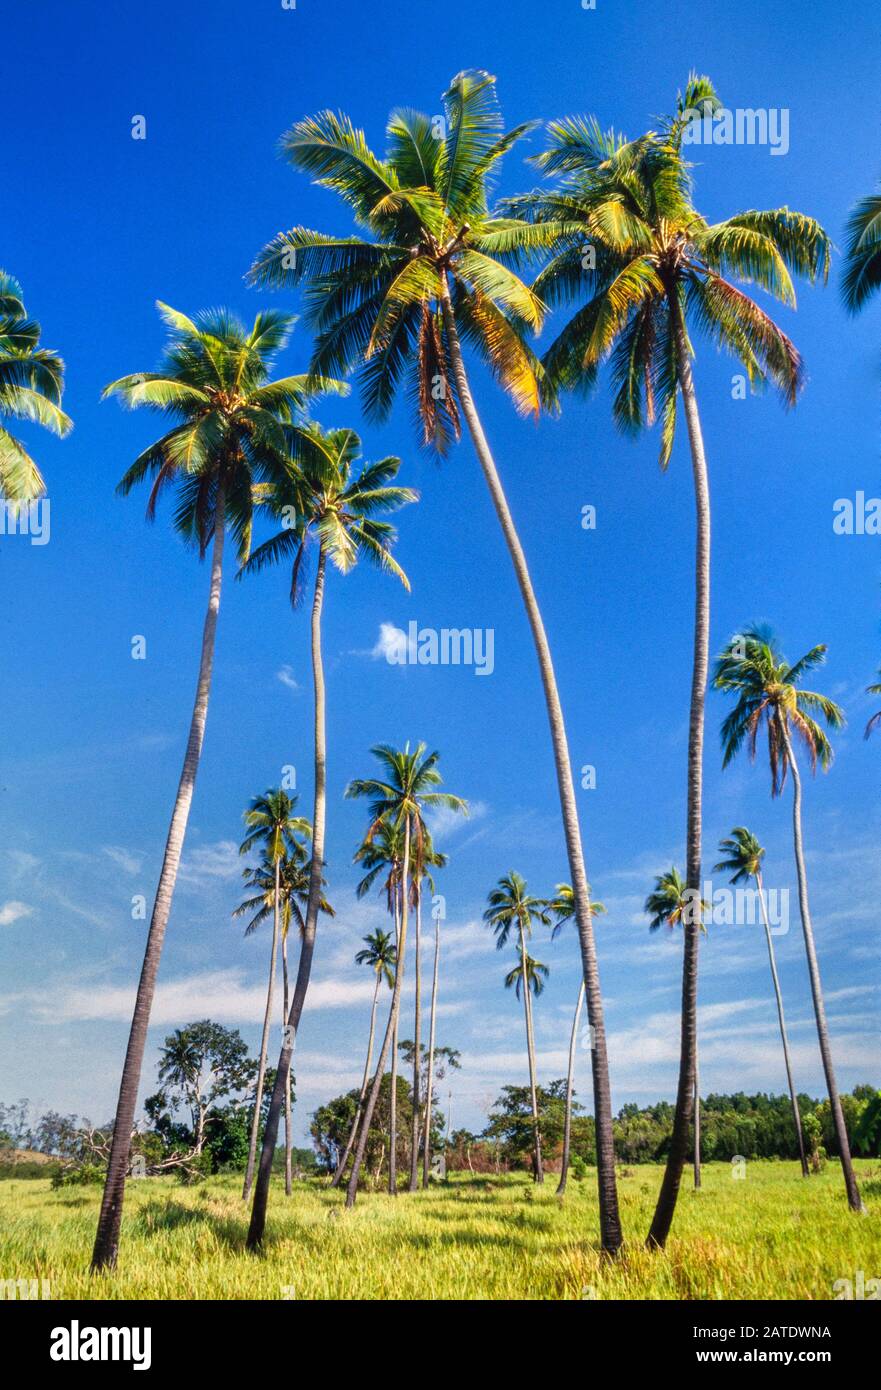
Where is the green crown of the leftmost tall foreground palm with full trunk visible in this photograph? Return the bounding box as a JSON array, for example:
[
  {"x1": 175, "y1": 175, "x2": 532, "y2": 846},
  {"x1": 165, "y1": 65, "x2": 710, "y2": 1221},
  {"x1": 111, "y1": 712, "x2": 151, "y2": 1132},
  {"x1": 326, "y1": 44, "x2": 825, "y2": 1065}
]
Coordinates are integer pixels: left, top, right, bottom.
[{"x1": 104, "y1": 303, "x2": 347, "y2": 559}]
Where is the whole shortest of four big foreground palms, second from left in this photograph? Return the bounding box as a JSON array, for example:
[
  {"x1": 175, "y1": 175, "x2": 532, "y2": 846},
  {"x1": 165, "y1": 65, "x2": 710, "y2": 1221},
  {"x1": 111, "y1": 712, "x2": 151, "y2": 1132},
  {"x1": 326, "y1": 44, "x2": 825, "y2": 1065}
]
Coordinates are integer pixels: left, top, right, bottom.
[{"x1": 246, "y1": 425, "x2": 417, "y2": 1250}]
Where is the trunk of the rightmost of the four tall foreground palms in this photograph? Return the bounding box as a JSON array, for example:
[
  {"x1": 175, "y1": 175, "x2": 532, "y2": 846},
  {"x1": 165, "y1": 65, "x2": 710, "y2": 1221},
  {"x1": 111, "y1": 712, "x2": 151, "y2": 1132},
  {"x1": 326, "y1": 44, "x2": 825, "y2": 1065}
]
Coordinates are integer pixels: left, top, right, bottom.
[{"x1": 646, "y1": 293, "x2": 710, "y2": 1248}]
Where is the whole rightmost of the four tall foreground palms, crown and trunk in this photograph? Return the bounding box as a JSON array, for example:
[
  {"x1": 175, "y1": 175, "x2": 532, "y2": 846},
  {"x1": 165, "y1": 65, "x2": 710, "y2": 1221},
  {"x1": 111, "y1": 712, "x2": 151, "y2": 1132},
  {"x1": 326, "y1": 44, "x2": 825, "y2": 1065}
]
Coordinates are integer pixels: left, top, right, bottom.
[{"x1": 504, "y1": 74, "x2": 830, "y2": 1247}]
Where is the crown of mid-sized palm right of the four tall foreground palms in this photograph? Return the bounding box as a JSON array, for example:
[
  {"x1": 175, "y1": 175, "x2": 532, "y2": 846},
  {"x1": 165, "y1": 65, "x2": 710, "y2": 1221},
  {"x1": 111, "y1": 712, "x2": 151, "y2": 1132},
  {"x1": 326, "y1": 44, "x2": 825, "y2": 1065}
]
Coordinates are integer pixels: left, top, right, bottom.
[{"x1": 713, "y1": 627, "x2": 845, "y2": 796}]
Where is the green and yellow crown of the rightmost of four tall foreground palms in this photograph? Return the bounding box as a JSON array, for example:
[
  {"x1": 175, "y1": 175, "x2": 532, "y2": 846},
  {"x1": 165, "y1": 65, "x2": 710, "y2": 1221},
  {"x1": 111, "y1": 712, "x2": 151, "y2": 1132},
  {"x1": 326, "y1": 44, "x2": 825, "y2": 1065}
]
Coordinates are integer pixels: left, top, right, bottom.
[{"x1": 504, "y1": 75, "x2": 830, "y2": 467}]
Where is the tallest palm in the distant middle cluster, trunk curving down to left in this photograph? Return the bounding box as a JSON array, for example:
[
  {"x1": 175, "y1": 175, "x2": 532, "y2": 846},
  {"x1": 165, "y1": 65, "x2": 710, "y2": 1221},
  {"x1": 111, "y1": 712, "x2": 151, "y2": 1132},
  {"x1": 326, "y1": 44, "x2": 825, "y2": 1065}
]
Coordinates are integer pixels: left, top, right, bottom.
[{"x1": 346, "y1": 744, "x2": 468, "y2": 1207}]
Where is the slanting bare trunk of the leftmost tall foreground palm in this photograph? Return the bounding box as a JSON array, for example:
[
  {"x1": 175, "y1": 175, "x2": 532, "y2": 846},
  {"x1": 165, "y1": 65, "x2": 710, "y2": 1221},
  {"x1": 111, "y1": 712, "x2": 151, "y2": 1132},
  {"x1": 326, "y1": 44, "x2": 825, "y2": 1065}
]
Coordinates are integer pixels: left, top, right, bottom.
[{"x1": 92, "y1": 482, "x2": 225, "y2": 1272}]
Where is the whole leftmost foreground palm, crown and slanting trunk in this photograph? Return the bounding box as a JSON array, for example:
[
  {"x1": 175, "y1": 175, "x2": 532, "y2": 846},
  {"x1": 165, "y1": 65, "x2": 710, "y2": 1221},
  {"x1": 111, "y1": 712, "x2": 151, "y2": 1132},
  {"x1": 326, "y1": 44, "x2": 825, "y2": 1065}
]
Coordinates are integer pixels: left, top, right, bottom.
[{"x1": 92, "y1": 303, "x2": 334, "y2": 1270}]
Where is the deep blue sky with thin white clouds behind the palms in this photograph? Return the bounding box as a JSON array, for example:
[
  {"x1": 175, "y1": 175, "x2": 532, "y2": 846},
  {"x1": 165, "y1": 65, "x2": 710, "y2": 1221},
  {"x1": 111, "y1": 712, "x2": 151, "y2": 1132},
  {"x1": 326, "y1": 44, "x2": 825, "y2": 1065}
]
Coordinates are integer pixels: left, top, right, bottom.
[{"x1": 0, "y1": 0, "x2": 881, "y2": 1136}]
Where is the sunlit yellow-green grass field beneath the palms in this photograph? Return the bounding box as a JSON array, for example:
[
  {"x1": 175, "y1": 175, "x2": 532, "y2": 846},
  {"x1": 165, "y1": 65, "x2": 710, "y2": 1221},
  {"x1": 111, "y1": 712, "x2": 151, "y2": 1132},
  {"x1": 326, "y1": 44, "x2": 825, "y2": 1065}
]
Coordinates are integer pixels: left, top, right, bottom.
[{"x1": 0, "y1": 1161, "x2": 881, "y2": 1300}]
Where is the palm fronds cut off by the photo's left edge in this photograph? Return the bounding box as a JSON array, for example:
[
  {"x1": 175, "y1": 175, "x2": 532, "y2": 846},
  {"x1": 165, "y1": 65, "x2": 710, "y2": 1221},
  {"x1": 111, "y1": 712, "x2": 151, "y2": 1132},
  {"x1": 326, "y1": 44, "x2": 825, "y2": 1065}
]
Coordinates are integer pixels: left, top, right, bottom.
[{"x1": 0, "y1": 270, "x2": 74, "y2": 503}]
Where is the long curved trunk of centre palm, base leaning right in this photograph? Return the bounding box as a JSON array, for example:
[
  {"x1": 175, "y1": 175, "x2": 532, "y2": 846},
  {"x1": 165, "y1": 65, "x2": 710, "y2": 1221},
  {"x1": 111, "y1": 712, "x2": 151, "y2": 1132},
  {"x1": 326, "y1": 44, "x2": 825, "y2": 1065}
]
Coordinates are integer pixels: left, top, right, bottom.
[{"x1": 441, "y1": 277, "x2": 624, "y2": 1255}]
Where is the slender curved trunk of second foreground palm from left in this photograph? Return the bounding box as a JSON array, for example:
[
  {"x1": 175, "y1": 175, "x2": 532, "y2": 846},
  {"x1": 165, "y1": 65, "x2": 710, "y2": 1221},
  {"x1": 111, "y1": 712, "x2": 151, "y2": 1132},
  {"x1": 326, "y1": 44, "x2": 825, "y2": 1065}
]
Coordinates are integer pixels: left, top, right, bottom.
[{"x1": 247, "y1": 546, "x2": 327, "y2": 1250}]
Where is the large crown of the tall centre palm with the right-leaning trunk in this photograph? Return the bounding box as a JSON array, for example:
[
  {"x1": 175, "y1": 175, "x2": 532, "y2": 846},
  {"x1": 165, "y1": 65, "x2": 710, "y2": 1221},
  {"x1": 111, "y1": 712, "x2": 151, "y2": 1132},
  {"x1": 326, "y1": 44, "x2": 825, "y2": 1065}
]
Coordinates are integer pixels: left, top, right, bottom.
[{"x1": 243, "y1": 71, "x2": 549, "y2": 452}]
